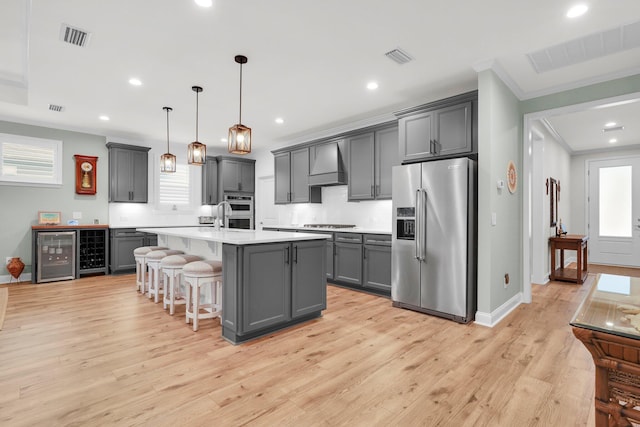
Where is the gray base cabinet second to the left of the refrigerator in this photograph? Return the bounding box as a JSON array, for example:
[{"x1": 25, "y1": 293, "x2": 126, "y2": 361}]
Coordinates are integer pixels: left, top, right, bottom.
[{"x1": 334, "y1": 233, "x2": 362, "y2": 286}]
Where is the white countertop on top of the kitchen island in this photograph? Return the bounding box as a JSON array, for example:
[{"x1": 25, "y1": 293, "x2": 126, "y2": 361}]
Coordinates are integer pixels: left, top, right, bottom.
[{"x1": 136, "y1": 227, "x2": 327, "y2": 245}]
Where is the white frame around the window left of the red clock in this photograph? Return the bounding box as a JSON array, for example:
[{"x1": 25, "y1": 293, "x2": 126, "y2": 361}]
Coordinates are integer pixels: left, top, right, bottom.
[{"x1": 0, "y1": 133, "x2": 63, "y2": 187}]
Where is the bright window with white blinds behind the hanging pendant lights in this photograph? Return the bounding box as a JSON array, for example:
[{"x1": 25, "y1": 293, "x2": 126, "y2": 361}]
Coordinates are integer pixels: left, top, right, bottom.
[{"x1": 156, "y1": 161, "x2": 195, "y2": 211}]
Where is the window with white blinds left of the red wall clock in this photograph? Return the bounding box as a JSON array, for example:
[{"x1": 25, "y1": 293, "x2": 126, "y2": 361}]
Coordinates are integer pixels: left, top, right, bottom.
[{"x1": 0, "y1": 133, "x2": 62, "y2": 187}]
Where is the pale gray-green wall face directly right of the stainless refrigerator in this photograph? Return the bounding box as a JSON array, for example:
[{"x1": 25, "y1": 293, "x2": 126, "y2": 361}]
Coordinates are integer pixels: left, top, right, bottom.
[{"x1": 478, "y1": 70, "x2": 522, "y2": 313}]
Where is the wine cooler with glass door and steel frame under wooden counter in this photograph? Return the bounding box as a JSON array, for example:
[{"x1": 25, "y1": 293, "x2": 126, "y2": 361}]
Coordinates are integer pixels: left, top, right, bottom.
[{"x1": 37, "y1": 231, "x2": 76, "y2": 283}]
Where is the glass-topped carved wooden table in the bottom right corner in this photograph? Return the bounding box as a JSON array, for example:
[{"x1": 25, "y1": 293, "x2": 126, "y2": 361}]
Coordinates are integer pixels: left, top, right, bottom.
[{"x1": 571, "y1": 274, "x2": 640, "y2": 427}]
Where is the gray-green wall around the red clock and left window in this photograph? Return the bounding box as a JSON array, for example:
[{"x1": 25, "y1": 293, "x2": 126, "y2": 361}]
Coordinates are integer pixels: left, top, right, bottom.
[{"x1": 0, "y1": 121, "x2": 109, "y2": 276}]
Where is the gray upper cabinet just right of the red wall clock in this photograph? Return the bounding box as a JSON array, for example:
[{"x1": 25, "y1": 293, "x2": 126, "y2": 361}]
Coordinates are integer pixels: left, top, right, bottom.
[{"x1": 107, "y1": 142, "x2": 150, "y2": 203}]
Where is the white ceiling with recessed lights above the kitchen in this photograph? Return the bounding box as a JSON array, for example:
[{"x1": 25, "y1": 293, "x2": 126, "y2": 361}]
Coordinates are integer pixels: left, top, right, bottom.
[{"x1": 0, "y1": 0, "x2": 640, "y2": 154}]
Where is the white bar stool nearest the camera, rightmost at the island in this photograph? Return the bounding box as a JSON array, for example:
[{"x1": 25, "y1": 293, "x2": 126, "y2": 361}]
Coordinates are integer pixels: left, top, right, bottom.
[{"x1": 182, "y1": 260, "x2": 222, "y2": 331}]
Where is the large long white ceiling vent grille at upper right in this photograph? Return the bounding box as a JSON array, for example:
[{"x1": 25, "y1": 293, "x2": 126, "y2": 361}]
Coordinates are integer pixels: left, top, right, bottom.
[{"x1": 527, "y1": 22, "x2": 640, "y2": 74}]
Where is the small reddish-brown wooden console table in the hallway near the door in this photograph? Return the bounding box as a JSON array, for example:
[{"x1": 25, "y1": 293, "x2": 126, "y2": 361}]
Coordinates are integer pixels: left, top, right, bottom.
[{"x1": 549, "y1": 234, "x2": 589, "y2": 283}]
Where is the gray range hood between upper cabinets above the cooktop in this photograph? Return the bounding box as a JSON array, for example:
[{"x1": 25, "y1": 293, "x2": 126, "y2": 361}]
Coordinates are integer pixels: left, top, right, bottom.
[{"x1": 309, "y1": 141, "x2": 347, "y2": 187}]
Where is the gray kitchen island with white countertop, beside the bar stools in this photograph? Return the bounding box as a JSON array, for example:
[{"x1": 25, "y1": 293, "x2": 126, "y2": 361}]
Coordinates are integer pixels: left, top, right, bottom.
[{"x1": 138, "y1": 227, "x2": 327, "y2": 344}]
